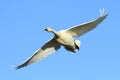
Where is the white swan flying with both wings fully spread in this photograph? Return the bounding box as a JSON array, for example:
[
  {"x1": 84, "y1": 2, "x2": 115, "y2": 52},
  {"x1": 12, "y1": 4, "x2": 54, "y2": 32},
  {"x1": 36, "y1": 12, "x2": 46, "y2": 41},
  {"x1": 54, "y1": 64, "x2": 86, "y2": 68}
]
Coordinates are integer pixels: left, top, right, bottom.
[{"x1": 16, "y1": 9, "x2": 108, "y2": 69}]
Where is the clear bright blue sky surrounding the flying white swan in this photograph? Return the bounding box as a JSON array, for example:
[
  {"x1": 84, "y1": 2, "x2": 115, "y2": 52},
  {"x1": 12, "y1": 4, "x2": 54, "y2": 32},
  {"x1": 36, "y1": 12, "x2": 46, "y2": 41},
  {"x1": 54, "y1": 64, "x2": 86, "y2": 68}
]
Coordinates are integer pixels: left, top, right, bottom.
[{"x1": 0, "y1": 0, "x2": 120, "y2": 80}]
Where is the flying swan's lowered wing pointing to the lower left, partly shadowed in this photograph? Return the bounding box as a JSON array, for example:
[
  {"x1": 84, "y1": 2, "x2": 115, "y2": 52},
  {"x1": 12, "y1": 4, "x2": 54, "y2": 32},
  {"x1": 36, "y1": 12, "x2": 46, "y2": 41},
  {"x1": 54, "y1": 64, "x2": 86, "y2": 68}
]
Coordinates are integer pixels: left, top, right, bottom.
[{"x1": 16, "y1": 38, "x2": 60, "y2": 69}]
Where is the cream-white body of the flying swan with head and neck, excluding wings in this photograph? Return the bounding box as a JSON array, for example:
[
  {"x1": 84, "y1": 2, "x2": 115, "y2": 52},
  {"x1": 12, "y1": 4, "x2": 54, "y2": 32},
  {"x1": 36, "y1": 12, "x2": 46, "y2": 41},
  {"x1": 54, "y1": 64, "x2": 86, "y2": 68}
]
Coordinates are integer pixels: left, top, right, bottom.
[{"x1": 45, "y1": 28, "x2": 80, "y2": 52}]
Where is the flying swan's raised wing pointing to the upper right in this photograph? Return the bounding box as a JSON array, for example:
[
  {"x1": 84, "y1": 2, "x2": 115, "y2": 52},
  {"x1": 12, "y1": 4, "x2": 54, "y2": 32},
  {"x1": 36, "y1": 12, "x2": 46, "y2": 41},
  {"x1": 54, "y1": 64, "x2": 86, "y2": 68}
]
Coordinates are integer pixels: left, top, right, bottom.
[{"x1": 66, "y1": 10, "x2": 108, "y2": 37}]
